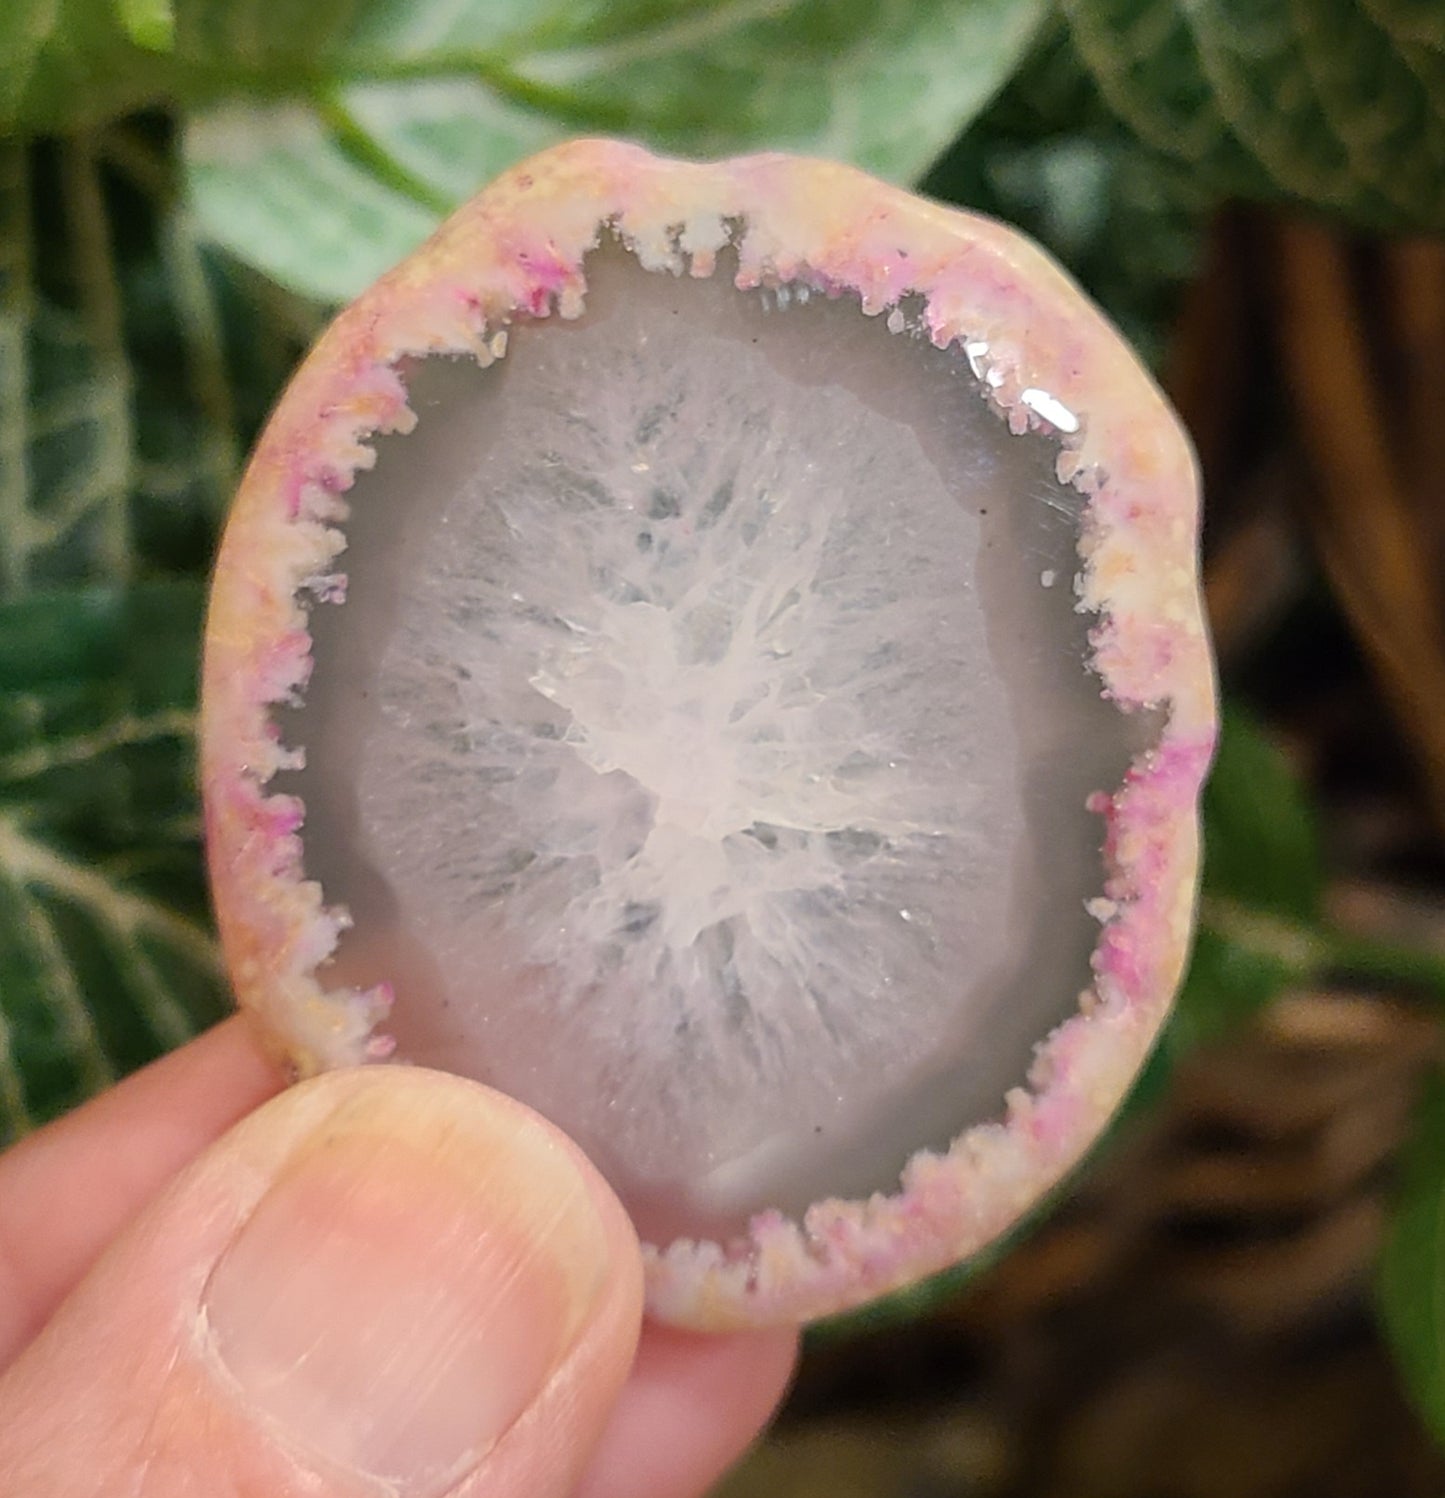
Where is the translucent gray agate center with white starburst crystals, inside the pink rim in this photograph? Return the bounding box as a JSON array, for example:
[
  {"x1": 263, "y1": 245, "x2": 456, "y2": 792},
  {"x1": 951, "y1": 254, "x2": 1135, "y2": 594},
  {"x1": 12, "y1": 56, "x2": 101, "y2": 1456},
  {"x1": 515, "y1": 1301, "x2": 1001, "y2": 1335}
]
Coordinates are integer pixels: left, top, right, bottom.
[{"x1": 285, "y1": 247, "x2": 1149, "y2": 1240}]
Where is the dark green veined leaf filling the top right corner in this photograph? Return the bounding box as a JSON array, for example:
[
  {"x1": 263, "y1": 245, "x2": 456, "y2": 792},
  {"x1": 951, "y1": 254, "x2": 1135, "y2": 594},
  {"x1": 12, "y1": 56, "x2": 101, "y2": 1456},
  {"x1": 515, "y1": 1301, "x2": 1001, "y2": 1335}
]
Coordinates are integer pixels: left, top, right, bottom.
[{"x1": 1060, "y1": 0, "x2": 1445, "y2": 231}]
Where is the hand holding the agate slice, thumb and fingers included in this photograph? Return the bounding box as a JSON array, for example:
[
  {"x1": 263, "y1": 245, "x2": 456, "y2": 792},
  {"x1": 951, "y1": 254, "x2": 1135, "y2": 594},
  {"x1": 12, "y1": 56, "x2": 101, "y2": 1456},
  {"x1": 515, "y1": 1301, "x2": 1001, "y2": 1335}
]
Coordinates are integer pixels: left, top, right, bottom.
[{"x1": 0, "y1": 1019, "x2": 795, "y2": 1498}]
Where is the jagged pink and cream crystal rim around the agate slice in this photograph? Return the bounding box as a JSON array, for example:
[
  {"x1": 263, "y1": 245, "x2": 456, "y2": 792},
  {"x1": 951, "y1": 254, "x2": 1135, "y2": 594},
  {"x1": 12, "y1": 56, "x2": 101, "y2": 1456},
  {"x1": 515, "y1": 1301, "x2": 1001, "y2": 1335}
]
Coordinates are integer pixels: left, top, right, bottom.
[{"x1": 201, "y1": 141, "x2": 1216, "y2": 1329}]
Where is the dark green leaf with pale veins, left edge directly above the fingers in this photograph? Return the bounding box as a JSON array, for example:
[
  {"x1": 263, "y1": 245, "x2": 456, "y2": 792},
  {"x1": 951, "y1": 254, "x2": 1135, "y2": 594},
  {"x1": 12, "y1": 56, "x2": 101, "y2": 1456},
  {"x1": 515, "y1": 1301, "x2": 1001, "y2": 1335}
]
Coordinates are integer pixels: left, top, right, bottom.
[{"x1": 0, "y1": 581, "x2": 226, "y2": 1144}]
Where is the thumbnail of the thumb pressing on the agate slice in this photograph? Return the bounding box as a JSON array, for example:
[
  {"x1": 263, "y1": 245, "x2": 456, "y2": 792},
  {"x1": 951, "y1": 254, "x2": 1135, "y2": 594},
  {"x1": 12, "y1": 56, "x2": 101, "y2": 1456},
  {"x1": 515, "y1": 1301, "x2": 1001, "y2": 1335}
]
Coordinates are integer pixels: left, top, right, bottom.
[{"x1": 205, "y1": 1071, "x2": 608, "y2": 1498}]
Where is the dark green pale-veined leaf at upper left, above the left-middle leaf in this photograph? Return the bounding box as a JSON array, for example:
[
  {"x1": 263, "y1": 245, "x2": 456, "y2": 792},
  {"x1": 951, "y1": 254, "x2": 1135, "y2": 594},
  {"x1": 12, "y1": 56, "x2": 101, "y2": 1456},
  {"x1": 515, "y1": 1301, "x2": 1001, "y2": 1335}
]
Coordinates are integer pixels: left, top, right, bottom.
[{"x1": 0, "y1": 127, "x2": 309, "y2": 596}]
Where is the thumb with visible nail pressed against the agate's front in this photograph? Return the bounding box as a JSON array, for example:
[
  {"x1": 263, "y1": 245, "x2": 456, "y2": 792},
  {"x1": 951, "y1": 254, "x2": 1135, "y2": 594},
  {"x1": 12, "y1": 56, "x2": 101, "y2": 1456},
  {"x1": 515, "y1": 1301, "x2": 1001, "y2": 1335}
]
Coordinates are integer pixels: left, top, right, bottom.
[{"x1": 0, "y1": 1067, "x2": 641, "y2": 1498}]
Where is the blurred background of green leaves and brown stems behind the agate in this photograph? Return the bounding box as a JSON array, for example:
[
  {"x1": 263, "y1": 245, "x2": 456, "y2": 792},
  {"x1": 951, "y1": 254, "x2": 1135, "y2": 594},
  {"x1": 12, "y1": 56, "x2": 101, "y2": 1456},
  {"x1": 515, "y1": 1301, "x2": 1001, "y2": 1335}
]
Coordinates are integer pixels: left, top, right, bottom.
[{"x1": 0, "y1": 0, "x2": 1445, "y2": 1498}]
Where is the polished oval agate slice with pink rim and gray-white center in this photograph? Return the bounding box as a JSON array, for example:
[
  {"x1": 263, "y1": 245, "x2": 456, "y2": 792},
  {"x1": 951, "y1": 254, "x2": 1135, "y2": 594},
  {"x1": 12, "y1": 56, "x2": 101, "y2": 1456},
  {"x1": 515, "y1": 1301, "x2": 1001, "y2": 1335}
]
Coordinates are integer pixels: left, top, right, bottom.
[{"x1": 204, "y1": 142, "x2": 1214, "y2": 1326}]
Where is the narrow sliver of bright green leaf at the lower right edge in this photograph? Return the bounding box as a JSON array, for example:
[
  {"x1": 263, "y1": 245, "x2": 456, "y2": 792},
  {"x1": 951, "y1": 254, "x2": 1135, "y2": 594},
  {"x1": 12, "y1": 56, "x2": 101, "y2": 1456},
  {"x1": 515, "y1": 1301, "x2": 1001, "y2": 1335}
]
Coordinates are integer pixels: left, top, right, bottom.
[{"x1": 1376, "y1": 1077, "x2": 1445, "y2": 1441}]
